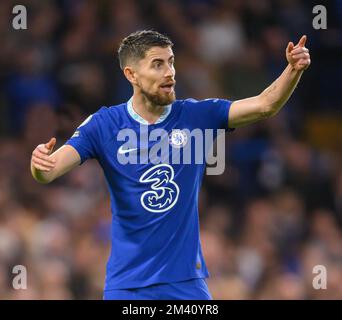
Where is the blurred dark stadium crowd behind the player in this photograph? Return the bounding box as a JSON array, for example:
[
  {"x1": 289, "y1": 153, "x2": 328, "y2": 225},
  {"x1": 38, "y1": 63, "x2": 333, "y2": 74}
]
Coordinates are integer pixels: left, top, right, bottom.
[{"x1": 0, "y1": 0, "x2": 342, "y2": 299}]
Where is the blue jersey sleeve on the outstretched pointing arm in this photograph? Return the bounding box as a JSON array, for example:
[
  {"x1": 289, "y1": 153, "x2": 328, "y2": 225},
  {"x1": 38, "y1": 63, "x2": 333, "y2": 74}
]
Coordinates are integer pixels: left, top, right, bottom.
[{"x1": 185, "y1": 99, "x2": 235, "y2": 132}]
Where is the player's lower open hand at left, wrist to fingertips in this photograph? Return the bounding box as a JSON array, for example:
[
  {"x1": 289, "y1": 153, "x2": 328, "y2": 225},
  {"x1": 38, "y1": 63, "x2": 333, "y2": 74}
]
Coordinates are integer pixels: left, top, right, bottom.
[{"x1": 31, "y1": 138, "x2": 56, "y2": 172}]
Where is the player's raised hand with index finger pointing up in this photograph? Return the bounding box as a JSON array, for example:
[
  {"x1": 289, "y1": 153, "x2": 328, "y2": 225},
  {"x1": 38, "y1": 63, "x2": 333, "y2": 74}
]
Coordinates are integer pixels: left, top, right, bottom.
[{"x1": 286, "y1": 35, "x2": 311, "y2": 71}]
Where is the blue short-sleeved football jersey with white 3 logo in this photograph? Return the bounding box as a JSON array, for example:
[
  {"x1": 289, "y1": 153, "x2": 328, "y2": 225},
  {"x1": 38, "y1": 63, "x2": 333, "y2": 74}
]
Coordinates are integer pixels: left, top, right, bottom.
[{"x1": 66, "y1": 99, "x2": 231, "y2": 290}]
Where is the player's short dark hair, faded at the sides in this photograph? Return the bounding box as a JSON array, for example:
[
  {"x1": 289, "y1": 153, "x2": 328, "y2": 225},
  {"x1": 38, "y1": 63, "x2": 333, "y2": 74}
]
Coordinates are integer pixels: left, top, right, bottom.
[{"x1": 118, "y1": 30, "x2": 173, "y2": 69}]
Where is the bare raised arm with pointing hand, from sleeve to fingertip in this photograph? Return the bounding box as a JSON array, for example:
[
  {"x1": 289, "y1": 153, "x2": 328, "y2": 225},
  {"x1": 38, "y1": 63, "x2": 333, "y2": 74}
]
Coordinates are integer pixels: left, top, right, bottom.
[{"x1": 228, "y1": 35, "x2": 311, "y2": 128}]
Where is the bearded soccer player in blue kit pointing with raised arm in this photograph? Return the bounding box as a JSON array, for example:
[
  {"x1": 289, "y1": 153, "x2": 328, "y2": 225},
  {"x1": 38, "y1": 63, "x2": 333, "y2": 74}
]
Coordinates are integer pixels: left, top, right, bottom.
[{"x1": 31, "y1": 30, "x2": 311, "y2": 300}]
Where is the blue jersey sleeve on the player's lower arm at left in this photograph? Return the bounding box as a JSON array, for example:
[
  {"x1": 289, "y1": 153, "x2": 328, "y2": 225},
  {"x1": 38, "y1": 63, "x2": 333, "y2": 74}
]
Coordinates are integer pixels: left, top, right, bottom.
[{"x1": 65, "y1": 114, "x2": 98, "y2": 165}]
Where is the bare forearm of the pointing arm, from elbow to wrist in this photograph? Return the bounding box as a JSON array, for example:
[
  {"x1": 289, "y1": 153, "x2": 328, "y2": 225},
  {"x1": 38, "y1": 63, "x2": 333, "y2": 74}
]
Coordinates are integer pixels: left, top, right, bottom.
[{"x1": 260, "y1": 64, "x2": 303, "y2": 115}]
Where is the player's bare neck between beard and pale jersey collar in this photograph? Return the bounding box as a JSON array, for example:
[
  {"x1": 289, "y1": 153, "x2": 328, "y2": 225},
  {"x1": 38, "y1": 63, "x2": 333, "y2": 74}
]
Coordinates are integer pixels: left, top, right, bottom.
[{"x1": 132, "y1": 95, "x2": 164, "y2": 124}]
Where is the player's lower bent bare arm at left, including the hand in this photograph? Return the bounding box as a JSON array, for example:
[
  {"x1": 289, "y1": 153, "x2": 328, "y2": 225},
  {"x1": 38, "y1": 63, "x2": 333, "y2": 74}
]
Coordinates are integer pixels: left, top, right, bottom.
[{"x1": 31, "y1": 138, "x2": 81, "y2": 183}]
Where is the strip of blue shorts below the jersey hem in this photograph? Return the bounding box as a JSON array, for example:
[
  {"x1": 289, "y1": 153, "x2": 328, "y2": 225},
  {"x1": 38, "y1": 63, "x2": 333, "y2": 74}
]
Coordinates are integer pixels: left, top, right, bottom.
[{"x1": 103, "y1": 278, "x2": 212, "y2": 300}]
